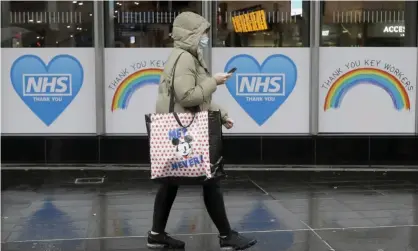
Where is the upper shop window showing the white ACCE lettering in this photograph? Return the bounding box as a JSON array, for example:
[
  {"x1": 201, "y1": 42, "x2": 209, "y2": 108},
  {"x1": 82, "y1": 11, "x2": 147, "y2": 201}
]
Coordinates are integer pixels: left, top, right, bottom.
[{"x1": 321, "y1": 1, "x2": 417, "y2": 47}]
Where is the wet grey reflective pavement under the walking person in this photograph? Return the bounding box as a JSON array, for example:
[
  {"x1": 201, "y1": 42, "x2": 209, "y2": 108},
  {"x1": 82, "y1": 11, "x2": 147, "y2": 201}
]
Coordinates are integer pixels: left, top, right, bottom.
[{"x1": 1, "y1": 171, "x2": 418, "y2": 251}]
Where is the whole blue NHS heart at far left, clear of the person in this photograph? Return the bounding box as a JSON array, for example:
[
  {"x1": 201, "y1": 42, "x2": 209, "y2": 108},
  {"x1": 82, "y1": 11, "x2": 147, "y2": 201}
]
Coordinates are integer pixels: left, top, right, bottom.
[{"x1": 10, "y1": 55, "x2": 84, "y2": 126}]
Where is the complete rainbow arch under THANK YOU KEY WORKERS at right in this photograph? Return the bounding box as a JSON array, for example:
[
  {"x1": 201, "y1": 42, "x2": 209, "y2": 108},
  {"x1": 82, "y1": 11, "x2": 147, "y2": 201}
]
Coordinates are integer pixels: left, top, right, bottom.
[{"x1": 324, "y1": 68, "x2": 411, "y2": 111}]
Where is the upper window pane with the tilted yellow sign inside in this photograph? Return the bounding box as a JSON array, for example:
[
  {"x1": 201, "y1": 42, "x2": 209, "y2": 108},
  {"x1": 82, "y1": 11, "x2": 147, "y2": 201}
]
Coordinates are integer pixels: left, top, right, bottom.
[{"x1": 212, "y1": 0, "x2": 310, "y2": 47}]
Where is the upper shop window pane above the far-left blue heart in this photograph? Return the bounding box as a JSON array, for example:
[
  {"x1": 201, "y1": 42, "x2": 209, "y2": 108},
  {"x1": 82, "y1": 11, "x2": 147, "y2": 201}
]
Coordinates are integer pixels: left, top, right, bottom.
[{"x1": 1, "y1": 1, "x2": 94, "y2": 48}]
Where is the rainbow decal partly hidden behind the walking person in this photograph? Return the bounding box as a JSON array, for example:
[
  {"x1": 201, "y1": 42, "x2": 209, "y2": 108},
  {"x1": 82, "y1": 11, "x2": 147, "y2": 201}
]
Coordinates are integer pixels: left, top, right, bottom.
[{"x1": 111, "y1": 68, "x2": 163, "y2": 112}]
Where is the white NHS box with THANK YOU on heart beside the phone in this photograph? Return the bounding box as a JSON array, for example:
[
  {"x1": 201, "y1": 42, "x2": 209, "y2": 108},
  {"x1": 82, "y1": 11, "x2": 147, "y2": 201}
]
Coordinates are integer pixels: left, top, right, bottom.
[{"x1": 236, "y1": 73, "x2": 286, "y2": 101}]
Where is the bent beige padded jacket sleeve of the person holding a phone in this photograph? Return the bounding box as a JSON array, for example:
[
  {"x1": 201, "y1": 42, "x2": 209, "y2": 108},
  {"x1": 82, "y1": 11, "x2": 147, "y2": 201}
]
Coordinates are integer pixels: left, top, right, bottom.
[{"x1": 172, "y1": 53, "x2": 217, "y2": 107}]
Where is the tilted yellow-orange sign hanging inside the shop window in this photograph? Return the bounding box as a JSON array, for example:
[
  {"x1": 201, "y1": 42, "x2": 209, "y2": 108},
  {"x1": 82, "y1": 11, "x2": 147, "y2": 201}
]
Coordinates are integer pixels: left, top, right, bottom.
[{"x1": 232, "y1": 10, "x2": 268, "y2": 32}]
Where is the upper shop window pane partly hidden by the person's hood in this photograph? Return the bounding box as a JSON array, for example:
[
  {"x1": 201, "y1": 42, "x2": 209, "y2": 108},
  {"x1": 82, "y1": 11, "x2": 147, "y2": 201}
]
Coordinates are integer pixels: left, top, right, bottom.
[{"x1": 105, "y1": 1, "x2": 202, "y2": 48}]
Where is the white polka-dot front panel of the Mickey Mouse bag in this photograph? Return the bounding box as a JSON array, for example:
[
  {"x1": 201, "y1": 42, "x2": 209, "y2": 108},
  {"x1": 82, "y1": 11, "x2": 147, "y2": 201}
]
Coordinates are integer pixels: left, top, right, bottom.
[{"x1": 150, "y1": 111, "x2": 211, "y2": 179}]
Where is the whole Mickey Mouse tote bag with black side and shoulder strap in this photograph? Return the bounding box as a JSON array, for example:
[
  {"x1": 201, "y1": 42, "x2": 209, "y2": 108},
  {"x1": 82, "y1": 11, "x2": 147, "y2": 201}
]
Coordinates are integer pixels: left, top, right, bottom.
[{"x1": 145, "y1": 54, "x2": 225, "y2": 184}]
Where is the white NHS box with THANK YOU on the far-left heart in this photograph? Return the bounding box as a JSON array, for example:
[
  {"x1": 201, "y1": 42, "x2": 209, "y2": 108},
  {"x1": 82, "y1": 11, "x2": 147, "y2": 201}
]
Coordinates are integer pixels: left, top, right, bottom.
[{"x1": 23, "y1": 74, "x2": 72, "y2": 101}]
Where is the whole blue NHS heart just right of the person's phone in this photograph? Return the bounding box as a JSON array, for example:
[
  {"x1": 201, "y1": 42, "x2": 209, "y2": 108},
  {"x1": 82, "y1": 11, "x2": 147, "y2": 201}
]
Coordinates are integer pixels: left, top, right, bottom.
[{"x1": 224, "y1": 54, "x2": 297, "y2": 126}]
